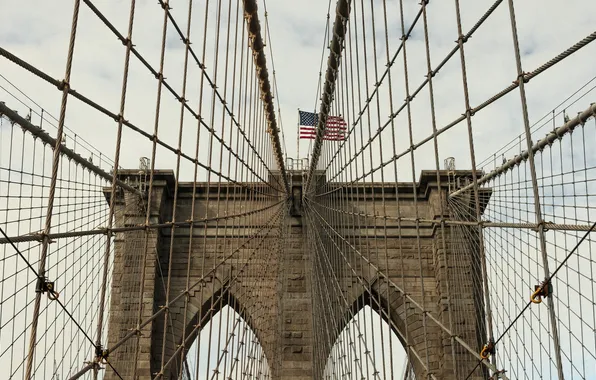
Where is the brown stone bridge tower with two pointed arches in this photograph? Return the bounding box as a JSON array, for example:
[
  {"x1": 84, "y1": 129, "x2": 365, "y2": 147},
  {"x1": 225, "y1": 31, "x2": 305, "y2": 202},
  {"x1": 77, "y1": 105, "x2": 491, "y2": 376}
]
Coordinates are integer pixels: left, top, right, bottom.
[{"x1": 104, "y1": 170, "x2": 490, "y2": 380}]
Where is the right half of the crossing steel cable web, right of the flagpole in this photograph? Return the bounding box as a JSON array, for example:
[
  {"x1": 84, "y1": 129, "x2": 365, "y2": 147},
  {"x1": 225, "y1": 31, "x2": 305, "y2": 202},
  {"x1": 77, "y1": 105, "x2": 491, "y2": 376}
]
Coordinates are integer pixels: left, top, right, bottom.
[{"x1": 305, "y1": 0, "x2": 596, "y2": 378}]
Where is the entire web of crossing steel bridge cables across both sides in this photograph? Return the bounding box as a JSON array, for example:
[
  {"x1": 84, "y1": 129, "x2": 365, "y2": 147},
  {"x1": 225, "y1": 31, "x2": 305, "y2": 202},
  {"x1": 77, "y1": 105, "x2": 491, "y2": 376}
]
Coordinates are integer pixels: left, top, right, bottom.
[{"x1": 0, "y1": 0, "x2": 596, "y2": 379}]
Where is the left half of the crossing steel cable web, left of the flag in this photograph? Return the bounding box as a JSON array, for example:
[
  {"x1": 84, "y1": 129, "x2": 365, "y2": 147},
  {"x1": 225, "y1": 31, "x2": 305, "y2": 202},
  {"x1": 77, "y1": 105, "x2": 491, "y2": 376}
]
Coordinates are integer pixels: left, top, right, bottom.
[{"x1": 0, "y1": 0, "x2": 288, "y2": 379}]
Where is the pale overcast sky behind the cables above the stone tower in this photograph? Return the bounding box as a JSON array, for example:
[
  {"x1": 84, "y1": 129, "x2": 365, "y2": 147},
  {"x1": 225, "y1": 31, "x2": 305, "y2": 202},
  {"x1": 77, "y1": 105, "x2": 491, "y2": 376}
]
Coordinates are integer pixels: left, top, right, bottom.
[{"x1": 0, "y1": 0, "x2": 596, "y2": 378}]
